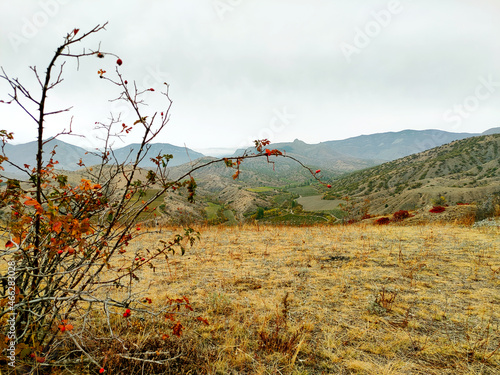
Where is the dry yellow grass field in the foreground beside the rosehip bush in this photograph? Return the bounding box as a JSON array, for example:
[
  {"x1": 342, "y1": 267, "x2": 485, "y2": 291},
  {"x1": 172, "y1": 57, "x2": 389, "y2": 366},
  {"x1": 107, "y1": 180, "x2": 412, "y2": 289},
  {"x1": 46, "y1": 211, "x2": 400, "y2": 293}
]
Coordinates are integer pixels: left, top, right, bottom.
[{"x1": 75, "y1": 224, "x2": 500, "y2": 375}]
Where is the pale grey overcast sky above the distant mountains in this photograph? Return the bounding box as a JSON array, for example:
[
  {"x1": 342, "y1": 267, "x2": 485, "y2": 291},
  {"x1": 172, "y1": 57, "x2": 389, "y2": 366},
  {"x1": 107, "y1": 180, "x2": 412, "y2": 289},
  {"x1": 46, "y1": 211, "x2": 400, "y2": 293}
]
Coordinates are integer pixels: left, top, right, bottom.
[{"x1": 0, "y1": 0, "x2": 500, "y2": 152}]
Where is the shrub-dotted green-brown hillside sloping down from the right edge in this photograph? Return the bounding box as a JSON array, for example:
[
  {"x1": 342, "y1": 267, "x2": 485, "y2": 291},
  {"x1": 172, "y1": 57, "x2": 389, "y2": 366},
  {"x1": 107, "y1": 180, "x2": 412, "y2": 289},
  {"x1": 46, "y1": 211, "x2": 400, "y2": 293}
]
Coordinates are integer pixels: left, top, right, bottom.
[{"x1": 325, "y1": 134, "x2": 500, "y2": 213}]
